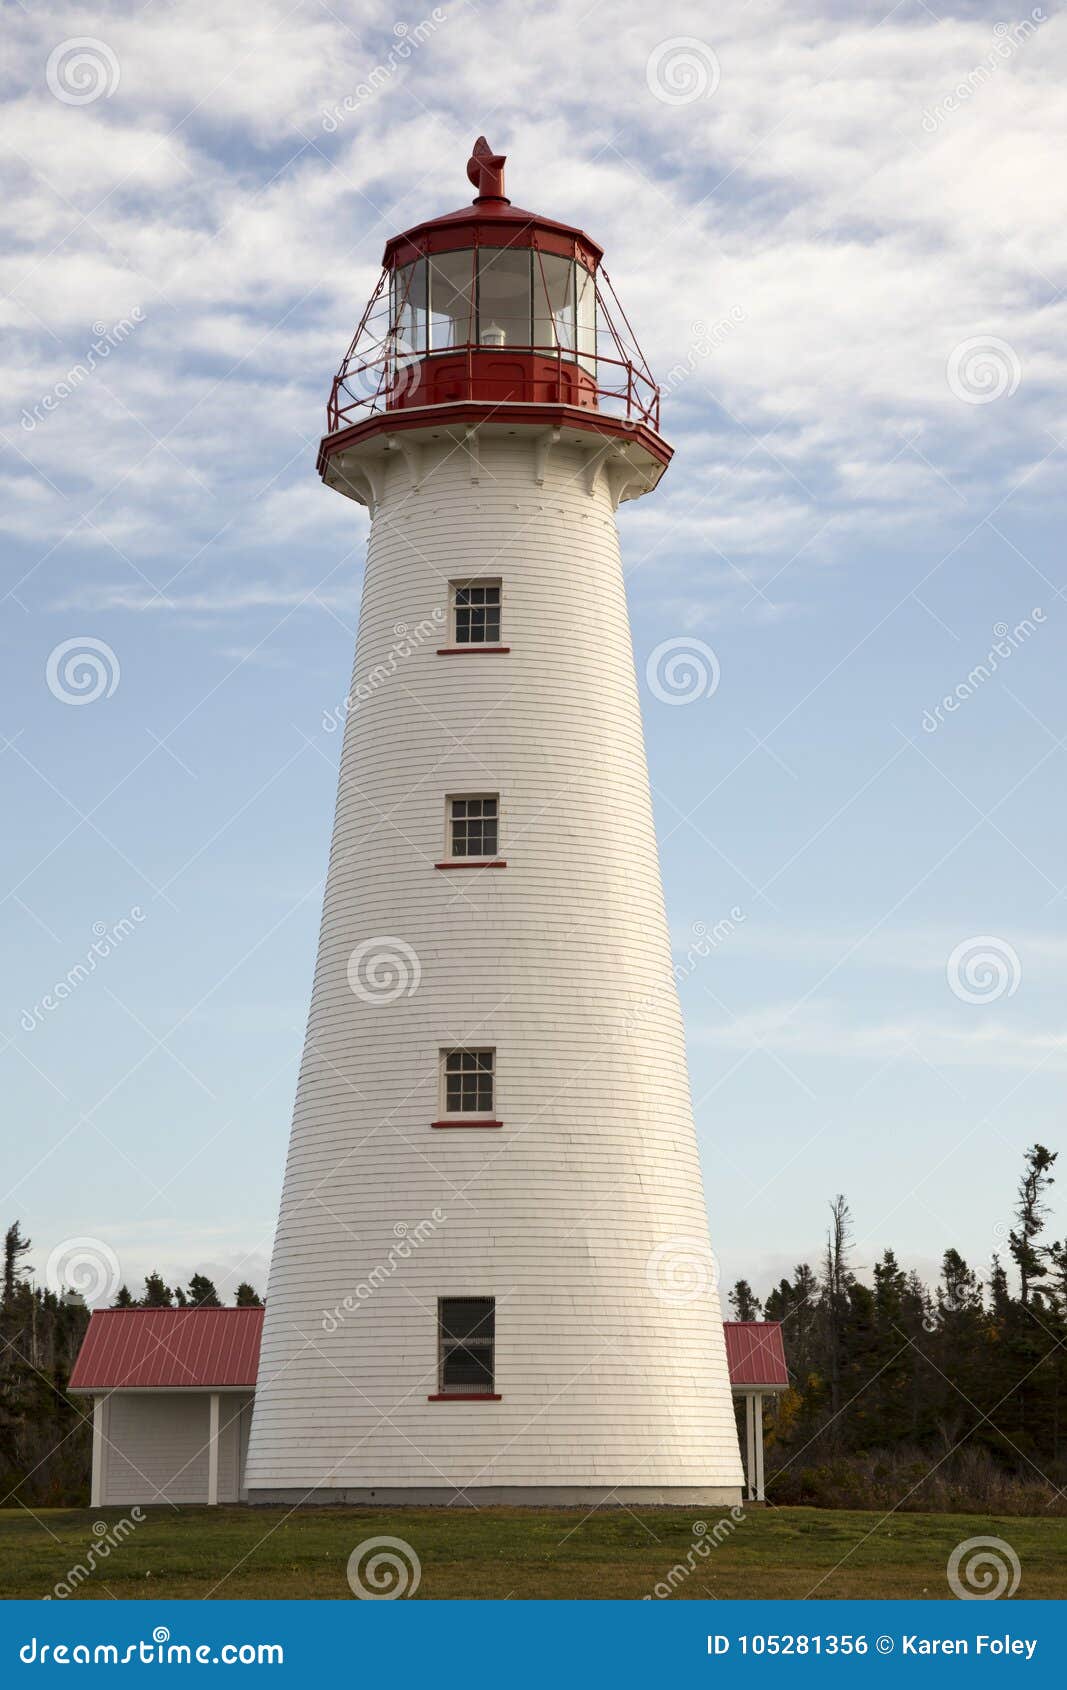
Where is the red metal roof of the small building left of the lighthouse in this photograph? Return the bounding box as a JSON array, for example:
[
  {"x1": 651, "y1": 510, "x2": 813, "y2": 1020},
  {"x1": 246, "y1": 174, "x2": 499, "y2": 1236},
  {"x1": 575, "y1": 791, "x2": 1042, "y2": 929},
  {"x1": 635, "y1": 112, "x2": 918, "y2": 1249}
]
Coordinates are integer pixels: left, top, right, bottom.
[{"x1": 71, "y1": 1308, "x2": 264, "y2": 1391}]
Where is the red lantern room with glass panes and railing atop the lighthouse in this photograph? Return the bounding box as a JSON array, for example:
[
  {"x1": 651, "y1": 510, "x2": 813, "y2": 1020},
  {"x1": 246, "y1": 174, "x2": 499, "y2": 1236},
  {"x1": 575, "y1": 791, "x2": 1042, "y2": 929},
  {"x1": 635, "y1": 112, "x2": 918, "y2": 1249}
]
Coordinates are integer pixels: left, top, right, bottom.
[{"x1": 320, "y1": 137, "x2": 671, "y2": 493}]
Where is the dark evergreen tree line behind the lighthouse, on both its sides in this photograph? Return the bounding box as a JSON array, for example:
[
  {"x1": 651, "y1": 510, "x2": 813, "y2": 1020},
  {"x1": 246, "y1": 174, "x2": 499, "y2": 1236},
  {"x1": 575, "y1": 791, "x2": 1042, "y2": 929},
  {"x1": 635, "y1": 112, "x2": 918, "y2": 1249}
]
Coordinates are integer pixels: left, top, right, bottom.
[{"x1": 0, "y1": 1144, "x2": 1067, "y2": 1514}]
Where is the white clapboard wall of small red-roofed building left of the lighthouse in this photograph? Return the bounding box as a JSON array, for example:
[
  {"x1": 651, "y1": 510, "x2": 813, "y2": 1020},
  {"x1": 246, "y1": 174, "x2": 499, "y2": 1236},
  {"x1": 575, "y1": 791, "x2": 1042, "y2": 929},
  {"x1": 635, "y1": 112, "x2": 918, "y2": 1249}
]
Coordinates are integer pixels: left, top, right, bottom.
[{"x1": 101, "y1": 1391, "x2": 252, "y2": 1507}]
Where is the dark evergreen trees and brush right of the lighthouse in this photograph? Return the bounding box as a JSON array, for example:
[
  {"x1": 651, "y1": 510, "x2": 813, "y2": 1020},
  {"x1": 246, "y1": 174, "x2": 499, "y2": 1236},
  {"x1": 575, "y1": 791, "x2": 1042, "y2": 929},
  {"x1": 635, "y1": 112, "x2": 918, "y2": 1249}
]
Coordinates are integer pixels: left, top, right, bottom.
[{"x1": 729, "y1": 1144, "x2": 1067, "y2": 1513}]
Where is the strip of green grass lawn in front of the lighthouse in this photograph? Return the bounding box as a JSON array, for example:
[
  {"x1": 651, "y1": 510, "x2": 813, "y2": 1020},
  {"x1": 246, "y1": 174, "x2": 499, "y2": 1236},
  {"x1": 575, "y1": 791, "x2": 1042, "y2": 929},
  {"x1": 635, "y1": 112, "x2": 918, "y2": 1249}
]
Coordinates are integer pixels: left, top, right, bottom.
[{"x1": 0, "y1": 1507, "x2": 1067, "y2": 1600}]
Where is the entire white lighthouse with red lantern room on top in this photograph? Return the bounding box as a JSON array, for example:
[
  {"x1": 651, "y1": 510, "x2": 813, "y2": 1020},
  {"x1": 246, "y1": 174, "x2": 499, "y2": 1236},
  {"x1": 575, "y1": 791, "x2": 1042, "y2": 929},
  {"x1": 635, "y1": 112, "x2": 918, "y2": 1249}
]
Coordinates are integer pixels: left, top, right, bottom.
[{"x1": 245, "y1": 140, "x2": 742, "y2": 1504}]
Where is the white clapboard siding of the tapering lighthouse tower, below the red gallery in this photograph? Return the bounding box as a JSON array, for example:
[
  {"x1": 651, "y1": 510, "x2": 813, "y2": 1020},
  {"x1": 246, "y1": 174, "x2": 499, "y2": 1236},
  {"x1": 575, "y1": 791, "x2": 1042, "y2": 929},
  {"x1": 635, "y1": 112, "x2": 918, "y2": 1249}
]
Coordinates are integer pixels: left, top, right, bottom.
[{"x1": 247, "y1": 429, "x2": 741, "y2": 1501}]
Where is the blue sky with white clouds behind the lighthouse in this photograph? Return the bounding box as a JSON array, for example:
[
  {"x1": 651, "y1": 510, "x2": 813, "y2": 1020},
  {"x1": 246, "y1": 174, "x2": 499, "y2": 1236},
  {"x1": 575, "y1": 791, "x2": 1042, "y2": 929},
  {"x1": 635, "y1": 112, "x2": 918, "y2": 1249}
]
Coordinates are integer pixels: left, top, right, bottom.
[{"x1": 0, "y1": 0, "x2": 1067, "y2": 1293}]
